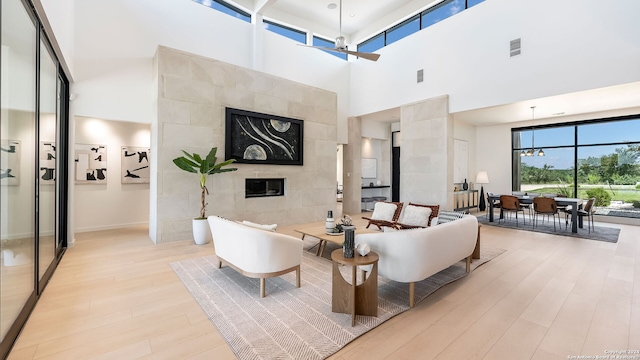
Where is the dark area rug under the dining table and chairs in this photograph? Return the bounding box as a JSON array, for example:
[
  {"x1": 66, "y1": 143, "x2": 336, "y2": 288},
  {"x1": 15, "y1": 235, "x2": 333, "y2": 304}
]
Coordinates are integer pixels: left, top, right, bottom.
[{"x1": 478, "y1": 215, "x2": 620, "y2": 243}]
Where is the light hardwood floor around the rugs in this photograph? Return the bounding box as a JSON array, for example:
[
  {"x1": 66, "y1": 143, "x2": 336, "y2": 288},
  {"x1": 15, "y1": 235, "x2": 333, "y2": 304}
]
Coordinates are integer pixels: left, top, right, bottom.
[{"x1": 9, "y1": 217, "x2": 640, "y2": 360}]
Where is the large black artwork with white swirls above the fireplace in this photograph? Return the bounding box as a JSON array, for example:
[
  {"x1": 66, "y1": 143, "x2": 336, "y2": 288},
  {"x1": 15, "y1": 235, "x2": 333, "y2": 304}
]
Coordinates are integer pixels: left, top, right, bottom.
[{"x1": 225, "y1": 107, "x2": 304, "y2": 165}]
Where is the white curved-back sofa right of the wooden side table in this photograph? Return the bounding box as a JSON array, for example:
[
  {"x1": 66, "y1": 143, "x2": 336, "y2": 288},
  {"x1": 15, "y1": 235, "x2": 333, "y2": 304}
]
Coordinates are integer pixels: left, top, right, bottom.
[{"x1": 355, "y1": 215, "x2": 478, "y2": 307}]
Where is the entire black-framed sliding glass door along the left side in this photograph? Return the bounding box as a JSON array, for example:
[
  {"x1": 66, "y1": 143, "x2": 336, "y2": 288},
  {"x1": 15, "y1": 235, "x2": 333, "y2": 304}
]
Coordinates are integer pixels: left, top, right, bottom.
[{"x1": 0, "y1": 0, "x2": 68, "y2": 358}]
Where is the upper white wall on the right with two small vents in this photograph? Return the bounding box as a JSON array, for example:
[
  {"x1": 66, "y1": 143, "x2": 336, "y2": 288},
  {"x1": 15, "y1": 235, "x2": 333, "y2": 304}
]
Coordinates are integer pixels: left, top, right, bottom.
[{"x1": 350, "y1": 0, "x2": 640, "y2": 116}]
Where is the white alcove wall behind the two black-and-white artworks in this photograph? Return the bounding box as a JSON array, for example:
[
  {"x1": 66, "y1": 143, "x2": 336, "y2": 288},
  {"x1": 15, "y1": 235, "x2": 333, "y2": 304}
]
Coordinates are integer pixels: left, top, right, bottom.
[{"x1": 70, "y1": 117, "x2": 154, "y2": 232}]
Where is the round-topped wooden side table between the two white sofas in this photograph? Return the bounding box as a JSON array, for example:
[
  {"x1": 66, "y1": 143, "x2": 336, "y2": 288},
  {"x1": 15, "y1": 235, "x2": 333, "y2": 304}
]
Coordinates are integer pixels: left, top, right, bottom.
[{"x1": 331, "y1": 249, "x2": 379, "y2": 326}]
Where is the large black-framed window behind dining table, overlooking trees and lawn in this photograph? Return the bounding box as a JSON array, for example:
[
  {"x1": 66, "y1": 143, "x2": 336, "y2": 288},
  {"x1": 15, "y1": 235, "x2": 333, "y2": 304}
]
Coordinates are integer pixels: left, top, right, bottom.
[{"x1": 512, "y1": 115, "x2": 640, "y2": 218}]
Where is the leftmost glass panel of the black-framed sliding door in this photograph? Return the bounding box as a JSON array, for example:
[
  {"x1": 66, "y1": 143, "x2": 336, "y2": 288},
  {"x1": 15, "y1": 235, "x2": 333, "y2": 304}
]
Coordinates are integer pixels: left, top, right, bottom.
[{"x1": 0, "y1": 0, "x2": 37, "y2": 342}]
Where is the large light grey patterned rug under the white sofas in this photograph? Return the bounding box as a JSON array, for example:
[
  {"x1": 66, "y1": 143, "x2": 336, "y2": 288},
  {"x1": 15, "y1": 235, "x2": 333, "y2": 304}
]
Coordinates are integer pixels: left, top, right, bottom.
[{"x1": 171, "y1": 248, "x2": 504, "y2": 359}]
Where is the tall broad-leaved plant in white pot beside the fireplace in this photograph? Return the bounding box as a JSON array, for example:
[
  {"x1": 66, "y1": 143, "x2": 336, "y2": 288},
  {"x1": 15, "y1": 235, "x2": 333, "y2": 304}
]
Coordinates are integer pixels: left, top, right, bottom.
[{"x1": 173, "y1": 147, "x2": 238, "y2": 245}]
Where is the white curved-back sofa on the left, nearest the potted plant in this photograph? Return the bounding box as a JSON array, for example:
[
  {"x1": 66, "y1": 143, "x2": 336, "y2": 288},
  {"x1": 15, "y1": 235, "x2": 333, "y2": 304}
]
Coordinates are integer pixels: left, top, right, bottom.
[{"x1": 207, "y1": 216, "x2": 303, "y2": 297}]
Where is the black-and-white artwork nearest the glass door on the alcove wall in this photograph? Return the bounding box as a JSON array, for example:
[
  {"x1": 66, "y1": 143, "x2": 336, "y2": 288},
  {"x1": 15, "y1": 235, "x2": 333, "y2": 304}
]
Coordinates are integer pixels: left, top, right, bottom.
[{"x1": 75, "y1": 144, "x2": 107, "y2": 184}]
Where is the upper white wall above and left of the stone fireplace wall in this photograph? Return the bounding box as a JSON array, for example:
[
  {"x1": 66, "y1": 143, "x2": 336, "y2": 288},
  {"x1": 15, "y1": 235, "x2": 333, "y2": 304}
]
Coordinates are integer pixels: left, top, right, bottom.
[{"x1": 72, "y1": 0, "x2": 350, "y2": 142}]
